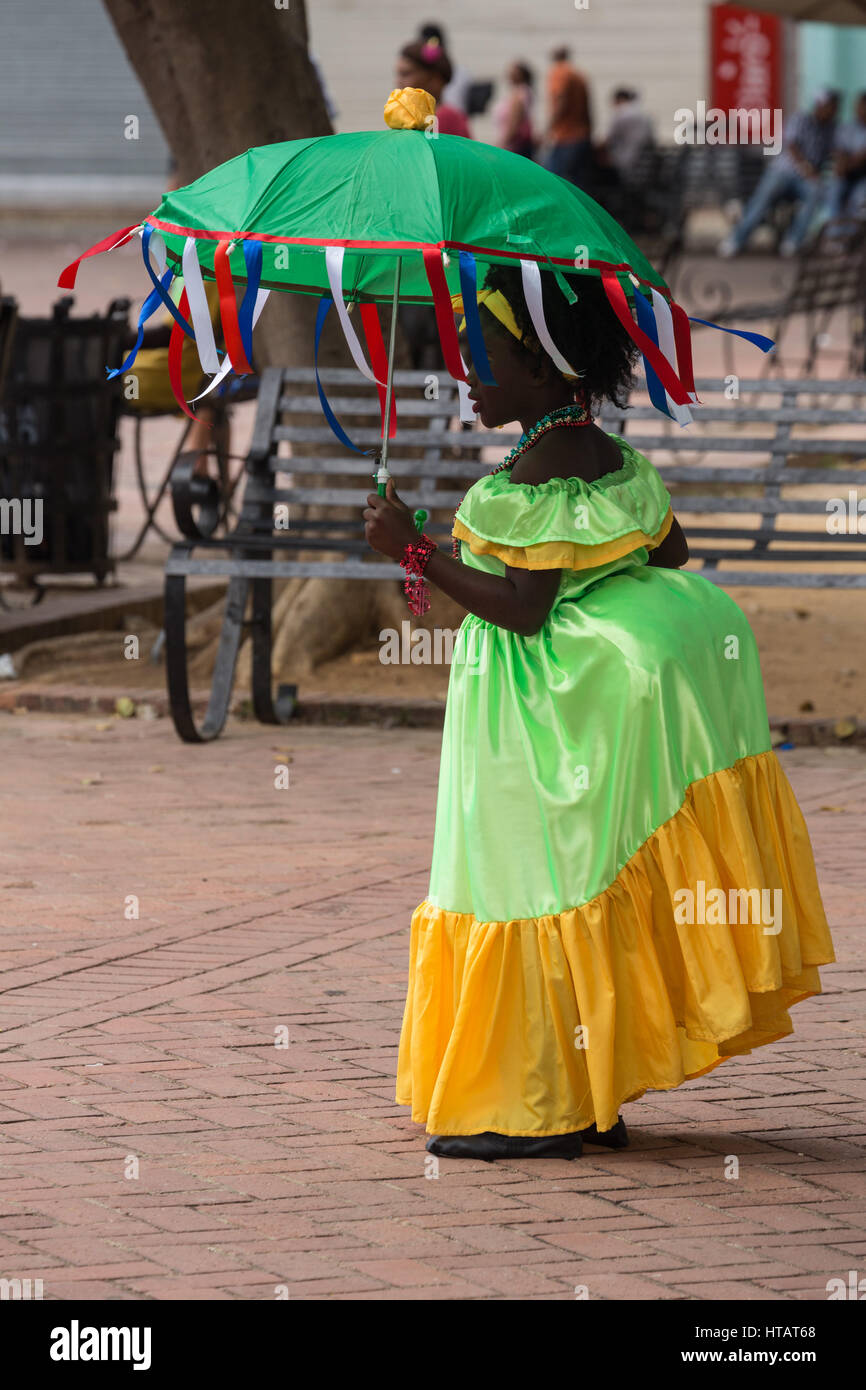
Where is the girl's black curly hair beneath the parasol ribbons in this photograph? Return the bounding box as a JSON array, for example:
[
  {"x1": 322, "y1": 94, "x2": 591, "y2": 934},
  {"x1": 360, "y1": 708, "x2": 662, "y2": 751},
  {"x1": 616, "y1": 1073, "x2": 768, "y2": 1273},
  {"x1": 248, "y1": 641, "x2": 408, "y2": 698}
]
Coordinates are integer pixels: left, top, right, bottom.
[{"x1": 484, "y1": 265, "x2": 638, "y2": 407}]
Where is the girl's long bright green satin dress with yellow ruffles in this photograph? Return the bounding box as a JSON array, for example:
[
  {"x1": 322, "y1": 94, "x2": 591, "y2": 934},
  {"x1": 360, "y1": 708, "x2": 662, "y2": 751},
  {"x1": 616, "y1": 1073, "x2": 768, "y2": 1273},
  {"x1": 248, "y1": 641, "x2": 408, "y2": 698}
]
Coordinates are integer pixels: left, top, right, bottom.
[{"x1": 396, "y1": 436, "x2": 835, "y2": 1136}]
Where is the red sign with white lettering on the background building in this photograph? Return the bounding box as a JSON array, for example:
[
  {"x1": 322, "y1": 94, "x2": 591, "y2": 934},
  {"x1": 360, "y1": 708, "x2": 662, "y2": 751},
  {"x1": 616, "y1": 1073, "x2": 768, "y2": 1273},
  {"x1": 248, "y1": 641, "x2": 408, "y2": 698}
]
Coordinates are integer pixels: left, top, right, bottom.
[{"x1": 710, "y1": 4, "x2": 784, "y2": 130}]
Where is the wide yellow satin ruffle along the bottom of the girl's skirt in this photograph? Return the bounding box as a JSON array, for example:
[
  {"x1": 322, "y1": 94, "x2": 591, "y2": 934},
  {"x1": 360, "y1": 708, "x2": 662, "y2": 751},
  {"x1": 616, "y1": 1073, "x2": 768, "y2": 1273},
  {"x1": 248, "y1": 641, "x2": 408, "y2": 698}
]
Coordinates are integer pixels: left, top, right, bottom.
[{"x1": 396, "y1": 752, "x2": 835, "y2": 1136}]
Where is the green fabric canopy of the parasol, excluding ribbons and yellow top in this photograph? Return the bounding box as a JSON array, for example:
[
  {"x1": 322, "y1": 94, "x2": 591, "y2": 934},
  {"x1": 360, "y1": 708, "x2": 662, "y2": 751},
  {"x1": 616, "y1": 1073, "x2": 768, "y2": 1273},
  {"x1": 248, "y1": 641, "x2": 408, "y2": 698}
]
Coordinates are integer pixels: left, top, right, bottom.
[{"x1": 140, "y1": 131, "x2": 664, "y2": 303}]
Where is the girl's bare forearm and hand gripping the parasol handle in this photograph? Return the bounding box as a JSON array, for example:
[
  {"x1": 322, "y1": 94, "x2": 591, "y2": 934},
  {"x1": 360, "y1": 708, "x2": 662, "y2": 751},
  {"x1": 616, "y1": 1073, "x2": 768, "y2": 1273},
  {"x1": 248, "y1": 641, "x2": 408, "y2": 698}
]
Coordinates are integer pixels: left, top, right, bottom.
[{"x1": 364, "y1": 480, "x2": 562, "y2": 637}]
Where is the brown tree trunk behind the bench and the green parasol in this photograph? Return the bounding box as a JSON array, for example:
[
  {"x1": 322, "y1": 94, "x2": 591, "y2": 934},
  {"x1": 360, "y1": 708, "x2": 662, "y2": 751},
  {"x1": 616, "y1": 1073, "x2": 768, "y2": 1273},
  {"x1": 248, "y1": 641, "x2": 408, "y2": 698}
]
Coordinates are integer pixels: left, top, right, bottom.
[{"x1": 103, "y1": 0, "x2": 463, "y2": 682}]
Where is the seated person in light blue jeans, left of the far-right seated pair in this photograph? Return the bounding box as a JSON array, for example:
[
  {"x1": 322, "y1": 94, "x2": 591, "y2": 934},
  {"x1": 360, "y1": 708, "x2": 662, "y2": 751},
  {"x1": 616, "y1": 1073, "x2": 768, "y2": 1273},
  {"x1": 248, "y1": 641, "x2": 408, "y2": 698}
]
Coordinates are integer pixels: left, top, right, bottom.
[{"x1": 717, "y1": 89, "x2": 840, "y2": 257}]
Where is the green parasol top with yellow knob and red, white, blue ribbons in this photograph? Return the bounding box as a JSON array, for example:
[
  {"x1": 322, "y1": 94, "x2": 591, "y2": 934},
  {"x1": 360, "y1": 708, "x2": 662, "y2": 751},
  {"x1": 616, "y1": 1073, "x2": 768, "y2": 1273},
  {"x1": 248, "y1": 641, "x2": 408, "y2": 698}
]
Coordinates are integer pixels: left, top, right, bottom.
[{"x1": 60, "y1": 89, "x2": 771, "y2": 472}]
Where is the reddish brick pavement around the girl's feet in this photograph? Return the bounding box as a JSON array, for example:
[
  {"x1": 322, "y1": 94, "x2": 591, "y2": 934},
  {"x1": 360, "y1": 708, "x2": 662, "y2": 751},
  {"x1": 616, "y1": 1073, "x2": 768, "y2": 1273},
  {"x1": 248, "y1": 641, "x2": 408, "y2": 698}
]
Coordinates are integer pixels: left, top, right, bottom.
[{"x1": 0, "y1": 714, "x2": 866, "y2": 1300}]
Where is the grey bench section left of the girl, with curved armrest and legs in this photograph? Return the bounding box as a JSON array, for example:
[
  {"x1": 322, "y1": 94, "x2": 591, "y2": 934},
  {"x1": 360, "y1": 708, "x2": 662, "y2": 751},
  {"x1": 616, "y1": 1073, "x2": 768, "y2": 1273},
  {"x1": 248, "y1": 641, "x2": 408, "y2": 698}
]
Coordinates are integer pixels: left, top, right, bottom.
[{"x1": 164, "y1": 367, "x2": 489, "y2": 742}]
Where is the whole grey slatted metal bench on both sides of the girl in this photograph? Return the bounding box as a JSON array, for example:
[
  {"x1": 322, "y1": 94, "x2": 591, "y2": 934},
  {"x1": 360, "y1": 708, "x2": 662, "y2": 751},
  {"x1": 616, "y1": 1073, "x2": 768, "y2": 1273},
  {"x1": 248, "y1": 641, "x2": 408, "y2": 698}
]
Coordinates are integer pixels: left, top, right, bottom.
[{"x1": 165, "y1": 367, "x2": 866, "y2": 742}]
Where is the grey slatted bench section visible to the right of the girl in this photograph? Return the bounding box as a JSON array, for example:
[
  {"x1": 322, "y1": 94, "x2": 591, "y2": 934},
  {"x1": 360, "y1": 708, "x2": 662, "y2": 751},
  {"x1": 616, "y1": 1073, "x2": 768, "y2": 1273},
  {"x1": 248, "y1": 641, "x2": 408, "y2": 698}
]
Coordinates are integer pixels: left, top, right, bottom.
[{"x1": 602, "y1": 378, "x2": 866, "y2": 589}]
